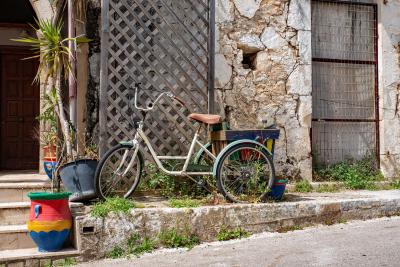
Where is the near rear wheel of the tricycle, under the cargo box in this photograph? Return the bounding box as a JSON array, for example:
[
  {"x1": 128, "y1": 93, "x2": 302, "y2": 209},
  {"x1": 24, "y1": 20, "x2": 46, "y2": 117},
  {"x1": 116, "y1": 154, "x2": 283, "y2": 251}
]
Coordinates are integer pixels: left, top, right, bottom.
[{"x1": 216, "y1": 143, "x2": 275, "y2": 202}]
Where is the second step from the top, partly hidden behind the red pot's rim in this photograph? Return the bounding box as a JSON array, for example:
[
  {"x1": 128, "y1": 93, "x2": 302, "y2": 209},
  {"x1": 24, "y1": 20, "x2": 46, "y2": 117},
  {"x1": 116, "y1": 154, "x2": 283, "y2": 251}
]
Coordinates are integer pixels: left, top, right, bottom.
[{"x1": 0, "y1": 202, "x2": 84, "y2": 226}]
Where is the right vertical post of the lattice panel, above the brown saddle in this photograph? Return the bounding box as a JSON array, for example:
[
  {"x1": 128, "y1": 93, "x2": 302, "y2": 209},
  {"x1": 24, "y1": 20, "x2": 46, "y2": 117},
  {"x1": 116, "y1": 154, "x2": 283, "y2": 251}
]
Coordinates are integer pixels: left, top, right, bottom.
[{"x1": 208, "y1": 0, "x2": 215, "y2": 114}]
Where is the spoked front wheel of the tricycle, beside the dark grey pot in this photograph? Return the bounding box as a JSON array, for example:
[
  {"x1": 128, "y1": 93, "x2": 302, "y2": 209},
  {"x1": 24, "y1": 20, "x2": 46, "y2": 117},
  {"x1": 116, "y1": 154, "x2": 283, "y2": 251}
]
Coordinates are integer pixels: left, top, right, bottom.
[{"x1": 95, "y1": 144, "x2": 144, "y2": 199}]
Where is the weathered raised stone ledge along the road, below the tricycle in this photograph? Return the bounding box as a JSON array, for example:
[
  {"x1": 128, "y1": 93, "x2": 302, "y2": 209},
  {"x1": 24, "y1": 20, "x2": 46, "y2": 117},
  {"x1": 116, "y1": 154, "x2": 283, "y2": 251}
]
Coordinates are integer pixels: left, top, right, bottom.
[{"x1": 77, "y1": 190, "x2": 400, "y2": 261}]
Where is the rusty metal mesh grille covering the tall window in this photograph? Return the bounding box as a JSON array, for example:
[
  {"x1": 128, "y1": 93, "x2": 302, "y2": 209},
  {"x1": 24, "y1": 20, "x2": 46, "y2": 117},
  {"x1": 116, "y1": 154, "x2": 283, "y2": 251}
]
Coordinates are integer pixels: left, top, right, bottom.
[{"x1": 312, "y1": 0, "x2": 379, "y2": 167}]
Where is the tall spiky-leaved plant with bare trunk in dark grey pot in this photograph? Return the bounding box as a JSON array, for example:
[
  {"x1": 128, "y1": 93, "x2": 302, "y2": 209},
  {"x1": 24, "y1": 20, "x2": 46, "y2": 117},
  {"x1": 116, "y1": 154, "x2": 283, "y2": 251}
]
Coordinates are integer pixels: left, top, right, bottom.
[{"x1": 16, "y1": 20, "x2": 97, "y2": 201}]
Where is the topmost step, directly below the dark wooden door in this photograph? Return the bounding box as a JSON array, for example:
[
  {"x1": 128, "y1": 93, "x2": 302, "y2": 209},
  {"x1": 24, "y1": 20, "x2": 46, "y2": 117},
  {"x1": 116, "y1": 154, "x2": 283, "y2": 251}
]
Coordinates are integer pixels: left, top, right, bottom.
[{"x1": 0, "y1": 181, "x2": 51, "y2": 203}]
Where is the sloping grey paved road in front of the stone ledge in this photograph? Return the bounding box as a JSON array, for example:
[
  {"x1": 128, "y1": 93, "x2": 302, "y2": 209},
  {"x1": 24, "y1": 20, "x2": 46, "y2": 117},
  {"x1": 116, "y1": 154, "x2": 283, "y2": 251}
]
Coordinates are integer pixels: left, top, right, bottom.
[{"x1": 78, "y1": 217, "x2": 400, "y2": 267}]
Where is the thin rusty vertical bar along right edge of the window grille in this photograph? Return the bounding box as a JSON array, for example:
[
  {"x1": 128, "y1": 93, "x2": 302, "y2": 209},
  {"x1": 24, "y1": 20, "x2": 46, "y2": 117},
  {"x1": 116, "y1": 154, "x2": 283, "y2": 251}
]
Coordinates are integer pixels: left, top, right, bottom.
[{"x1": 374, "y1": 5, "x2": 381, "y2": 168}]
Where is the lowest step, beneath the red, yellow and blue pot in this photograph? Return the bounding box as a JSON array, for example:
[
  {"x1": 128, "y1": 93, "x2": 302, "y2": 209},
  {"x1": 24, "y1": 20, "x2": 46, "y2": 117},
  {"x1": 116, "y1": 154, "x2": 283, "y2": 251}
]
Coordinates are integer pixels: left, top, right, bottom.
[{"x1": 0, "y1": 248, "x2": 80, "y2": 266}]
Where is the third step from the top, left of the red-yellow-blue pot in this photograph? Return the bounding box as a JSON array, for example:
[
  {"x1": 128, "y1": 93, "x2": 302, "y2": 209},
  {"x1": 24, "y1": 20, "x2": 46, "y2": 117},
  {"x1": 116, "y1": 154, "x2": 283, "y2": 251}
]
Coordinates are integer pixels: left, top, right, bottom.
[{"x1": 0, "y1": 224, "x2": 36, "y2": 251}]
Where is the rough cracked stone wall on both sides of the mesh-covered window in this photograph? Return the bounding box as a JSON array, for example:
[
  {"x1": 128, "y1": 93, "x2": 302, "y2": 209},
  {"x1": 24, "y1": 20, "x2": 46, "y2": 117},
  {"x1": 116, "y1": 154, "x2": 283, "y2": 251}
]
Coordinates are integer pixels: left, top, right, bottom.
[{"x1": 215, "y1": 0, "x2": 400, "y2": 179}]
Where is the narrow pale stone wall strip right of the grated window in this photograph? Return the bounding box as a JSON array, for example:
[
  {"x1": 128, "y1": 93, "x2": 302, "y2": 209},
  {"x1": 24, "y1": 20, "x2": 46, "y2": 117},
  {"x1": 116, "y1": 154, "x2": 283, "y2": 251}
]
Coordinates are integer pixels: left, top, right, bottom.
[{"x1": 379, "y1": 0, "x2": 400, "y2": 177}]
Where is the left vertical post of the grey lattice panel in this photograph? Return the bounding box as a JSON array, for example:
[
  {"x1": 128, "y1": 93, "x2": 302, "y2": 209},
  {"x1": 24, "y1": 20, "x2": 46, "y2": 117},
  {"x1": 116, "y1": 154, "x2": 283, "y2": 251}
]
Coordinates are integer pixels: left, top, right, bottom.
[{"x1": 99, "y1": 0, "x2": 110, "y2": 156}]
